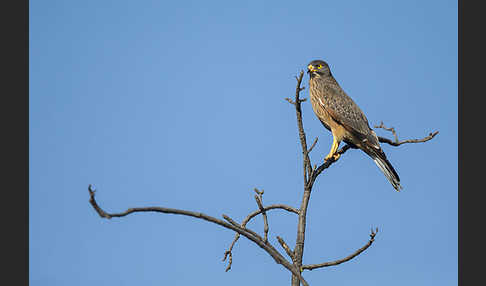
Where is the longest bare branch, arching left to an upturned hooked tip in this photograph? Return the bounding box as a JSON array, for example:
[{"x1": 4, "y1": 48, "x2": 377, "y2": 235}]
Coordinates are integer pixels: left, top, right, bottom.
[{"x1": 88, "y1": 185, "x2": 309, "y2": 286}]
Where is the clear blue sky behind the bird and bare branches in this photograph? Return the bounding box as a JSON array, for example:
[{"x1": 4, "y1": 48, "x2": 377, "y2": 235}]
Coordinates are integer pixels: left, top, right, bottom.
[{"x1": 29, "y1": 0, "x2": 458, "y2": 286}]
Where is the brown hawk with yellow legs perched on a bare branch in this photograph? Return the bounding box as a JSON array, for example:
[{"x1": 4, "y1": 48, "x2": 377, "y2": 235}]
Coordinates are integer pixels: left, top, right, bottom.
[{"x1": 307, "y1": 60, "x2": 402, "y2": 191}]
